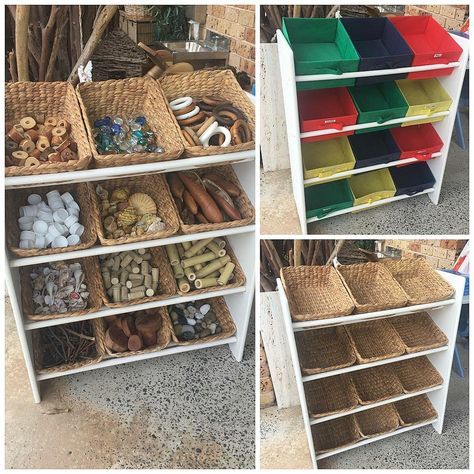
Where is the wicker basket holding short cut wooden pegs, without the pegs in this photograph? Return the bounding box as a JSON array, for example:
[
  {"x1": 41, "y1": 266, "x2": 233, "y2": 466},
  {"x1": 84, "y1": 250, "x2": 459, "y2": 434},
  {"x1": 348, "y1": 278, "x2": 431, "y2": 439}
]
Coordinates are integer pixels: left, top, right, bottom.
[{"x1": 99, "y1": 247, "x2": 178, "y2": 308}]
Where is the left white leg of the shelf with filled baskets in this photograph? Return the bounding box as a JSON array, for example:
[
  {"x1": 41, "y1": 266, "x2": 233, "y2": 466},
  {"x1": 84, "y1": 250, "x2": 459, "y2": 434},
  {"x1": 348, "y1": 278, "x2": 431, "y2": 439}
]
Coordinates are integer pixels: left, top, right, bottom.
[{"x1": 5, "y1": 259, "x2": 41, "y2": 403}]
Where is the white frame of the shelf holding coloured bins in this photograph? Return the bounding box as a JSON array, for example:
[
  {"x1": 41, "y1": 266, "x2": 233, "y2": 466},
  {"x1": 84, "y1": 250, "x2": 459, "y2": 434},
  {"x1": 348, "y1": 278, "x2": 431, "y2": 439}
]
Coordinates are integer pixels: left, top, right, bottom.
[{"x1": 277, "y1": 30, "x2": 469, "y2": 235}]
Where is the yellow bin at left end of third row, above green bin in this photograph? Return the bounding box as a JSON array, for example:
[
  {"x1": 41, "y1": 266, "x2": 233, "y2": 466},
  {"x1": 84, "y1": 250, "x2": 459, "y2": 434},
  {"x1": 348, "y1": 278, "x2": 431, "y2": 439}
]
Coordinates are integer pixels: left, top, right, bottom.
[{"x1": 301, "y1": 137, "x2": 355, "y2": 179}]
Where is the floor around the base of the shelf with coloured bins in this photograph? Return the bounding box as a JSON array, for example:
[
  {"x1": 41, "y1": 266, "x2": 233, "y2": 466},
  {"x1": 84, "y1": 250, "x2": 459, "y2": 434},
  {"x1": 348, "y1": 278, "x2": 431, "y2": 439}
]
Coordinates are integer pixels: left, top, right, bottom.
[{"x1": 260, "y1": 112, "x2": 469, "y2": 235}]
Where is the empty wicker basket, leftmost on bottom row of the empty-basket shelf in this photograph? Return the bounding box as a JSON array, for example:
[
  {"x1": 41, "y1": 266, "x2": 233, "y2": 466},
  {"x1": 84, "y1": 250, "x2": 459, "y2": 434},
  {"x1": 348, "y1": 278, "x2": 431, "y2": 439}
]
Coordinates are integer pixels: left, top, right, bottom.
[{"x1": 311, "y1": 415, "x2": 362, "y2": 454}]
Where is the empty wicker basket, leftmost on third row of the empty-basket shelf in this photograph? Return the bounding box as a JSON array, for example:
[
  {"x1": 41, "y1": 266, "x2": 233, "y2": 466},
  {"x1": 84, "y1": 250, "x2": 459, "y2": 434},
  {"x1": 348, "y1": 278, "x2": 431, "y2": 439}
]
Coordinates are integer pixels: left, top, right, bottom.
[{"x1": 304, "y1": 374, "x2": 358, "y2": 418}]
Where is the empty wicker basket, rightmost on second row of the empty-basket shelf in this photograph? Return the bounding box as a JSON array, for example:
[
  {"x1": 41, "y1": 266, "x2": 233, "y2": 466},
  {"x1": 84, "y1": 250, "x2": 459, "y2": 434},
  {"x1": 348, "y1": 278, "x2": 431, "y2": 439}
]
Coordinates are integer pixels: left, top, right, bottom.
[{"x1": 390, "y1": 313, "x2": 448, "y2": 353}]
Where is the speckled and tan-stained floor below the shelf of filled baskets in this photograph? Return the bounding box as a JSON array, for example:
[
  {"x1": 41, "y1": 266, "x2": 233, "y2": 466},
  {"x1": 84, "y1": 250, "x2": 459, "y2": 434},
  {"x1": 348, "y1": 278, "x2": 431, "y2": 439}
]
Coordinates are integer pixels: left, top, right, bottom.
[{"x1": 5, "y1": 298, "x2": 255, "y2": 469}]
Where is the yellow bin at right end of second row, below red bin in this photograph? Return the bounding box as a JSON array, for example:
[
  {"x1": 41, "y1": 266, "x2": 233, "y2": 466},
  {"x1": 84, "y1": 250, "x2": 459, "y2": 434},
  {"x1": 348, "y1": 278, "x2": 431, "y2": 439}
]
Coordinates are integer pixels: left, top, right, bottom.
[{"x1": 396, "y1": 78, "x2": 453, "y2": 127}]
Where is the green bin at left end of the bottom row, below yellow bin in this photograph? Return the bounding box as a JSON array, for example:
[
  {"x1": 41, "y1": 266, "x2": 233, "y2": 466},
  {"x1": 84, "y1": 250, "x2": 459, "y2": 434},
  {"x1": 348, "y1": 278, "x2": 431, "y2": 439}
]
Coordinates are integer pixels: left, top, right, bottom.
[{"x1": 304, "y1": 179, "x2": 353, "y2": 218}]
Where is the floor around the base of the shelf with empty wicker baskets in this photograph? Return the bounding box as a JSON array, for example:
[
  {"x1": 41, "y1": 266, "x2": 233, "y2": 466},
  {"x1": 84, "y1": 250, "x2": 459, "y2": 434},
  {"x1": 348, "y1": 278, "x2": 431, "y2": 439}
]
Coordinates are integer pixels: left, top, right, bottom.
[{"x1": 260, "y1": 344, "x2": 469, "y2": 469}]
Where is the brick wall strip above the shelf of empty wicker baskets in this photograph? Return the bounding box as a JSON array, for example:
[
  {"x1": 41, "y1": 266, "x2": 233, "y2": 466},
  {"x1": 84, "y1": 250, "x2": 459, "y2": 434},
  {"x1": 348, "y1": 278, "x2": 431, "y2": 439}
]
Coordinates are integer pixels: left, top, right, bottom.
[{"x1": 383, "y1": 239, "x2": 467, "y2": 269}]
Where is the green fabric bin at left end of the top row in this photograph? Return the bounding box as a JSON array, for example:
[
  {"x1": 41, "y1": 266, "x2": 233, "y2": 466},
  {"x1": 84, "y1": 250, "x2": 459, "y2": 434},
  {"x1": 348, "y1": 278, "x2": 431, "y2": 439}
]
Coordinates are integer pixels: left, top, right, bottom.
[{"x1": 282, "y1": 18, "x2": 360, "y2": 90}]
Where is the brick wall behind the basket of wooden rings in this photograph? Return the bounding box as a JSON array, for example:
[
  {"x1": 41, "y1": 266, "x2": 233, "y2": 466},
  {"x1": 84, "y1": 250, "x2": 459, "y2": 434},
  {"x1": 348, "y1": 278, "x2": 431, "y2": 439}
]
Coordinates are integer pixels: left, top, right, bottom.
[{"x1": 206, "y1": 5, "x2": 255, "y2": 78}]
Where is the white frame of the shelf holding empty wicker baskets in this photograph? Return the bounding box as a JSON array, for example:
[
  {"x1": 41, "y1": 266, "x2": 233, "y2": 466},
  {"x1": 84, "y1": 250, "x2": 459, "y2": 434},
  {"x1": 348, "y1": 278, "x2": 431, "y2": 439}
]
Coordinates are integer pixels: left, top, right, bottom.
[{"x1": 277, "y1": 272, "x2": 465, "y2": 469}]
